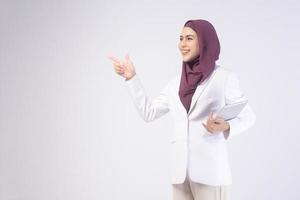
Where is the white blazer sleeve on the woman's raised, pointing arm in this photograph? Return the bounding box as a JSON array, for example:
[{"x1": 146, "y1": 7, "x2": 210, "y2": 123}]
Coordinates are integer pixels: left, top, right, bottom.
[{"x1": 126, "y1": 74, "x2": 169, "y2": 122}]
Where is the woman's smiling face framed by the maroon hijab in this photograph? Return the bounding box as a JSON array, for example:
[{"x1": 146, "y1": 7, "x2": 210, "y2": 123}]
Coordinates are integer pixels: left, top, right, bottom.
[{"x1": 178, "y1": 27, "x2": 202, "y2": 62}]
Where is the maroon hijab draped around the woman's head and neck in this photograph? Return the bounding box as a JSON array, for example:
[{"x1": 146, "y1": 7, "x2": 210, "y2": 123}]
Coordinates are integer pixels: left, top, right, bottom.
[{"x1": 178, "y1": 19, "x2": 220, "y2": 112}]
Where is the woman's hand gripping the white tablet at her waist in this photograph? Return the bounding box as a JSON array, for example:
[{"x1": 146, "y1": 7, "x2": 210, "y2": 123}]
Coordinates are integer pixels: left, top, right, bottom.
[{"x1": 202, "y1": 113, "x2": 230, "y2": 133}]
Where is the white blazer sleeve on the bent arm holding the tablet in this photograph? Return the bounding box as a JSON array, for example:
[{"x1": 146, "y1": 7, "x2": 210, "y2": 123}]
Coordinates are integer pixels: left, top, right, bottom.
[{"x1": 224, "y1": 72, "x2": 256, "y2": 140}]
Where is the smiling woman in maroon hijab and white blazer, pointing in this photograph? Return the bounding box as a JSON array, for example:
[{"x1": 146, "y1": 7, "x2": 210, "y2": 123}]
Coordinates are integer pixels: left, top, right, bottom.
[{"x1": 110, "y1": 20, "x2": 255, "y2": 200}]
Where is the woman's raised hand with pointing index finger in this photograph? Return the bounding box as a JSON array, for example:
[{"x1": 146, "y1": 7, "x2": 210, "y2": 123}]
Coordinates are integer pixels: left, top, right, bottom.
[{"x1": 108, "y1": 54, "x2": 136, "y2": 81}]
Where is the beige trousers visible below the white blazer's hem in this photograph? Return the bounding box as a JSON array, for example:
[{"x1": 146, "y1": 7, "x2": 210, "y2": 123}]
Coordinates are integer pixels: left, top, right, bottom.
[{"x1": 172, "y1": 176, "x2": 228, "y2": 200}]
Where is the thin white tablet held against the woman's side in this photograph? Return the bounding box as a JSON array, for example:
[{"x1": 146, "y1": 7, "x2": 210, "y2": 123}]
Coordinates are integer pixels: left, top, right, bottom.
[{"x1": 214, "y1": 100, "x2": 248, "y2": 120}]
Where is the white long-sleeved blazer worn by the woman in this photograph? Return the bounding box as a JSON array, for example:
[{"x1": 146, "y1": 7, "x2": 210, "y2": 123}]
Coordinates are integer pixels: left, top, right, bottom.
[{"x1": 126, "y1": 65, "x2": 255, "y2": 186}]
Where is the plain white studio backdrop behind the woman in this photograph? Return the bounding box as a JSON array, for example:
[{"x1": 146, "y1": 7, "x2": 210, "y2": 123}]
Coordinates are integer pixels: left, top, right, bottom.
[{"x1": 0, "y1": 0, "x2": 300, "y2": 200}]
